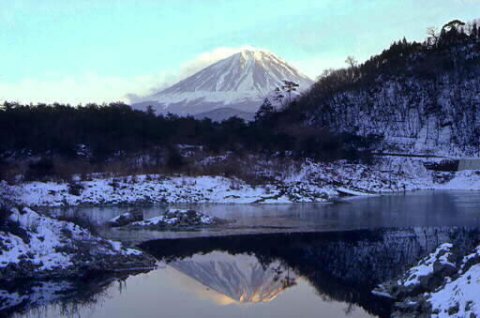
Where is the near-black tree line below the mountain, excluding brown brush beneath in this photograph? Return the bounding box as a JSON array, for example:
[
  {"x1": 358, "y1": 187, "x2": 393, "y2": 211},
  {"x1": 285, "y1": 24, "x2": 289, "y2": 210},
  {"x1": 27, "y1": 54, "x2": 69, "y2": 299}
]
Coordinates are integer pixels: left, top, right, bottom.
[{"x1": 0, "y1": 103, "x2": 376, "y2": 162}]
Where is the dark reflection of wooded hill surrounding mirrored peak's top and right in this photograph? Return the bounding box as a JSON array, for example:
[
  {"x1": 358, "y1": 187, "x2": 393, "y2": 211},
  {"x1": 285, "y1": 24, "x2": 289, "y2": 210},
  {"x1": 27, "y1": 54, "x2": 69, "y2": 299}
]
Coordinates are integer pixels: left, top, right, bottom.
[{"x1": 142, "y1": 228, "x2": 478, "y2": 316}]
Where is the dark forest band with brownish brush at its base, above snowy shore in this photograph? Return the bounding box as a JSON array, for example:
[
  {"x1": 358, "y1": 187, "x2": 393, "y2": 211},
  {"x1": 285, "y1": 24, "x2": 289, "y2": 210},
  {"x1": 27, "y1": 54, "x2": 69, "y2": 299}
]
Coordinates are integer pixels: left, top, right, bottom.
[{"x1": 0, "y1": 103, "x2": 370, "y2": 180}]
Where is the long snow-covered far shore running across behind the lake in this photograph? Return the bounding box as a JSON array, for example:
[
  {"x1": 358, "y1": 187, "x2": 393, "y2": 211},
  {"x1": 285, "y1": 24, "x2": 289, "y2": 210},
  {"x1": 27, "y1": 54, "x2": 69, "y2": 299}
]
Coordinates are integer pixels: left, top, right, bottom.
[{"x1": 2, "y1": 157, "x2": 480, "y2": 207}]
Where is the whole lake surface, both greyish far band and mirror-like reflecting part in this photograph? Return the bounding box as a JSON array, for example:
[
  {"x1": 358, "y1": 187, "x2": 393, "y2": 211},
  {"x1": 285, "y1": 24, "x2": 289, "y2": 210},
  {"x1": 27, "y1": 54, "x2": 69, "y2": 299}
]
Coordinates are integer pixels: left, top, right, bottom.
[{"x1": 0, "y1": 192, "x2": 480, "y2": 318}]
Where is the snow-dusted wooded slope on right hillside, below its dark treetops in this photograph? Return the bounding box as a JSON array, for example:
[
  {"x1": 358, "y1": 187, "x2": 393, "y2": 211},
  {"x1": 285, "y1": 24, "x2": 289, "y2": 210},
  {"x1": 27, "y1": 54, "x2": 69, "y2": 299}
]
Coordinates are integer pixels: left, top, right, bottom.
[{"x1": 304, "y1": 45, "x2": 480, "y2": 158}]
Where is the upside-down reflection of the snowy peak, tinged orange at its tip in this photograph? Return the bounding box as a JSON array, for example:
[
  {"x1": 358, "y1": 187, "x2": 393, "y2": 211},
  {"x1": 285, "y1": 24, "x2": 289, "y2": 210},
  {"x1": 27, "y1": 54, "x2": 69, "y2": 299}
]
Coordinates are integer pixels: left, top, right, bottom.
[{"x1": 169, "y1": 252, "x2": 295, "y2": 303}]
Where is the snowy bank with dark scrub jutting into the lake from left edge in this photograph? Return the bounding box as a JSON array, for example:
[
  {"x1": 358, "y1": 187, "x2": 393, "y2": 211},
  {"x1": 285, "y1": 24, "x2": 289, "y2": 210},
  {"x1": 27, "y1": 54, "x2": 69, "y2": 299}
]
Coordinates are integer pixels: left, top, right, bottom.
[{"x1": 0, "y1": 208, "x2": 155, "y2": 281}]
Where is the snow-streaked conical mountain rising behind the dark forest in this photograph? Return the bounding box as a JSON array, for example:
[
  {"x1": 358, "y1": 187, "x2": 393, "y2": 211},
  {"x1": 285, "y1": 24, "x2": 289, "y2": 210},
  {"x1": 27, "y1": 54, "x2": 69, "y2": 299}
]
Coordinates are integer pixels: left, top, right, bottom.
[{"x1": 134, "y1": 49, "x2": 313, "y2": 119}]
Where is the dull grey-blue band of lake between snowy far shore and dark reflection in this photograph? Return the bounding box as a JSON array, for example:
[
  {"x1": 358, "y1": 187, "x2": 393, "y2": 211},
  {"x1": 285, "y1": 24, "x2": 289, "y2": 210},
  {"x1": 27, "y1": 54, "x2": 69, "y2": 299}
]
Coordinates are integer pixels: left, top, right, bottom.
[{"x1": 51, "y1": 191, "x2": 480, "y2": 243}]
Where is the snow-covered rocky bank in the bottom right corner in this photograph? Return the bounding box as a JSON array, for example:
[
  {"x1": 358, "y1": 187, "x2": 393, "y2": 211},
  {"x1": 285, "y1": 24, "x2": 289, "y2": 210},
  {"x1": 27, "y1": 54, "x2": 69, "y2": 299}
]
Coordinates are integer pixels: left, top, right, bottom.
[{"x1": 373, "y1": 243, "x2": 480, "y2": 317}]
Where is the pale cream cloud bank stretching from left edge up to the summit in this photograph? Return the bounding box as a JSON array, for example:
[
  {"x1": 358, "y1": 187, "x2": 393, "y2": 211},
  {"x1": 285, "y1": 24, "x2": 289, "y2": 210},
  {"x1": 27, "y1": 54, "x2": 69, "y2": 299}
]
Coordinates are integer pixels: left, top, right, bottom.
[{"x1": 0, "y1": 46, "x2": 258, "y2": 105}]
